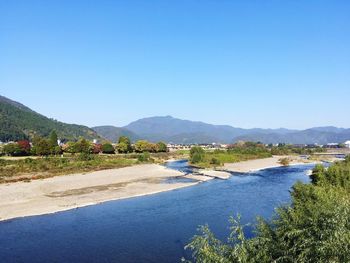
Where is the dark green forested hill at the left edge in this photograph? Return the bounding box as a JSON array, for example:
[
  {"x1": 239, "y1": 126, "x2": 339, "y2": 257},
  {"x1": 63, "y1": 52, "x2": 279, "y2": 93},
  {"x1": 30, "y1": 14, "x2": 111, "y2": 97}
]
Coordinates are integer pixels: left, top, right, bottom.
[{"x1": 0, "y1": 96, "x2": 99, "y2": 141}]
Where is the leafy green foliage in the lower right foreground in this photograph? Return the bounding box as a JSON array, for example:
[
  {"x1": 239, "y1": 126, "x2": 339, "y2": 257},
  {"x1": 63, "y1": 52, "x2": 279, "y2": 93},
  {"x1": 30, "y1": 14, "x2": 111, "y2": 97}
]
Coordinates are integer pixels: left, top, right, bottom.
[{"x1": 187, "y1": 157, "x2": 350, "y2": 263}]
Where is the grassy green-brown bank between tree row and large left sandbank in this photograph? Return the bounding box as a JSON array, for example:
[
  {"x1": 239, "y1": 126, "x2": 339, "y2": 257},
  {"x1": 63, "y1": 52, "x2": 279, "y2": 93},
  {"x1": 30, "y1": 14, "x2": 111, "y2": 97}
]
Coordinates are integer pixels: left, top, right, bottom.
[{"x1": 0, "y1": 152, "x2": 190, "y2": 183}]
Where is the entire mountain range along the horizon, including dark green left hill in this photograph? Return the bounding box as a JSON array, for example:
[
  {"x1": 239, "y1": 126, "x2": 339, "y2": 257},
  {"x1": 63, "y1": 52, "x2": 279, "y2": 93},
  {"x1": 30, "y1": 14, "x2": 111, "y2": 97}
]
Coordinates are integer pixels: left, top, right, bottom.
[{"x1": 0, "y1": 96, "x2": 350, "y2": 144}]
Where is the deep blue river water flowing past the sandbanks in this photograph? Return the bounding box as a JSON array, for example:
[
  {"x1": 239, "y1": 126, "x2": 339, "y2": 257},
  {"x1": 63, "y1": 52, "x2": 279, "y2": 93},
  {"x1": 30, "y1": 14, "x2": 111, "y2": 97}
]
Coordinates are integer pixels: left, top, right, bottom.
[{"x1": 0, "y1": 162, "x2": 313, "y2": 263}]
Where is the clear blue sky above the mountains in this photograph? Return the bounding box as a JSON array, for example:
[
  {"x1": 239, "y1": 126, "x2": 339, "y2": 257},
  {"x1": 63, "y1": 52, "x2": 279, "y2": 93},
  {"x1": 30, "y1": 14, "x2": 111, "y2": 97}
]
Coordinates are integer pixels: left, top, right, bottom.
[{"x1": 0, "y1": 0, "x2": 350, "y2": 129}]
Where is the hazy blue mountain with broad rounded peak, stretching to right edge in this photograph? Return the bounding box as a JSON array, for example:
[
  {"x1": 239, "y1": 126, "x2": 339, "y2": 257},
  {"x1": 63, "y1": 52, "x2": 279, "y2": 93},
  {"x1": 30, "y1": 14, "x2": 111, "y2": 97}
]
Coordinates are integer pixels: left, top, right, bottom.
[{"x1": 124, "y1": 116, "x2": 350, "y2": 144}]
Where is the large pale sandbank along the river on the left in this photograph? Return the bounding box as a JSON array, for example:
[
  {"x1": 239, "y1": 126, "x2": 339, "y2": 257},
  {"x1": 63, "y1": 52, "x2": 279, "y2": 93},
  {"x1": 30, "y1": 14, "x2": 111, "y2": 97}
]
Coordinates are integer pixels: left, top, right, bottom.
[{"x1": 0, "y1": 164, "x2": 198, "y2": 223}]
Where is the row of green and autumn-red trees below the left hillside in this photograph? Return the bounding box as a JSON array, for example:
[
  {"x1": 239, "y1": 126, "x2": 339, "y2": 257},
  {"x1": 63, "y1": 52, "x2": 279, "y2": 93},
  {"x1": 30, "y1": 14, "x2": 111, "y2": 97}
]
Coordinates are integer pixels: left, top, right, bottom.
[{"x1": 1, "y1": 131, "x2": 167, "y2": 156}]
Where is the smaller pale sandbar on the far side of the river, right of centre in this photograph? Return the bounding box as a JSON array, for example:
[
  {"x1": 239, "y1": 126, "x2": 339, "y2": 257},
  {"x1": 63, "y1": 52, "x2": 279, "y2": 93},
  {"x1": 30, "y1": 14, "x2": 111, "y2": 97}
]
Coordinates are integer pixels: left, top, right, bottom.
[{"x1": 223, "y1": 156, "x2": 315, "y2": 173}]
